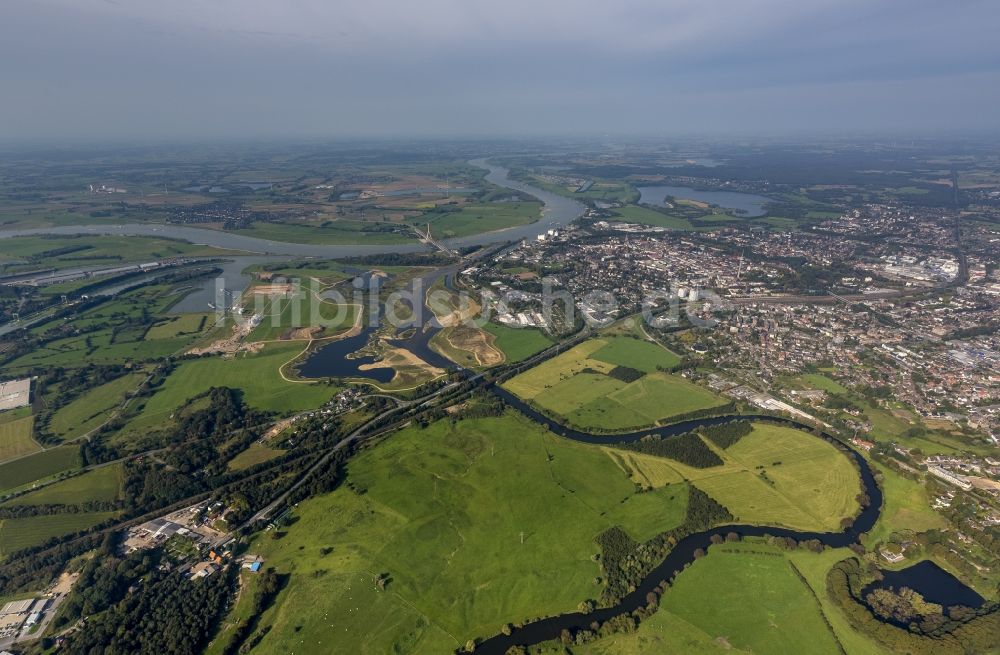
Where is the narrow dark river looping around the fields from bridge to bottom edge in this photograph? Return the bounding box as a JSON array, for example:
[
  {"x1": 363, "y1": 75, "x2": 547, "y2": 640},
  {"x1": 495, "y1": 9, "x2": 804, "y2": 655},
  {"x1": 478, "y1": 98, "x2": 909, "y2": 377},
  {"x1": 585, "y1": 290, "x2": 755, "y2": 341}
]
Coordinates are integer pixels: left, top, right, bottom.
[{"x1": 476, "y1": 386, "x2": 882, "y2": 655}]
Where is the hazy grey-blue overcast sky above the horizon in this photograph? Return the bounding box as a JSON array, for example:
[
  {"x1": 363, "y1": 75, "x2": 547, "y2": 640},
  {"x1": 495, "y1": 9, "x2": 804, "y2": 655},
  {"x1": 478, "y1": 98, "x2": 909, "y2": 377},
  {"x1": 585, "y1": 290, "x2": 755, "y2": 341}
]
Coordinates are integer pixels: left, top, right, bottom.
[{"x1": 0, "y1": 0, "x2": 1000, "y2": 141}]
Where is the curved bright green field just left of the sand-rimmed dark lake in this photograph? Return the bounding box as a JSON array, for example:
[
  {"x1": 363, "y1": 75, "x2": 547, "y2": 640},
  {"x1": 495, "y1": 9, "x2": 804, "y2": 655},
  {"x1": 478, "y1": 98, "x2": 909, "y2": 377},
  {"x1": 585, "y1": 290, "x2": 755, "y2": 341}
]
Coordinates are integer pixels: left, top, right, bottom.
[{"x1": 125, "y1": 343, "x2": 339, "y2": 431}]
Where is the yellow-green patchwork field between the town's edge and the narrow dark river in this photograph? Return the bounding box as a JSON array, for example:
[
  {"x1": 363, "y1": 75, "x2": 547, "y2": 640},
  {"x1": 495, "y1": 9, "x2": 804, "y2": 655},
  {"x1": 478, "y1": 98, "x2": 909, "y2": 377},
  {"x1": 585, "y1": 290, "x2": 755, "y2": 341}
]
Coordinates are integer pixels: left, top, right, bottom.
[{"x1": 504, "y1": 337, "x2": 726, "y2": 431}]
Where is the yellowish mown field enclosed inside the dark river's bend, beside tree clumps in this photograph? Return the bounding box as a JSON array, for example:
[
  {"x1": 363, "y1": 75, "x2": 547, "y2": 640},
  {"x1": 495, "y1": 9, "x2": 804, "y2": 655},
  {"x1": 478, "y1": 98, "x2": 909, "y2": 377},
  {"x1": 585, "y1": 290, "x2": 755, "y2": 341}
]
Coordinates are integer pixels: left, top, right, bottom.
[{"x1": 614, "y1": 424, "x2": 861, "y2": 531}]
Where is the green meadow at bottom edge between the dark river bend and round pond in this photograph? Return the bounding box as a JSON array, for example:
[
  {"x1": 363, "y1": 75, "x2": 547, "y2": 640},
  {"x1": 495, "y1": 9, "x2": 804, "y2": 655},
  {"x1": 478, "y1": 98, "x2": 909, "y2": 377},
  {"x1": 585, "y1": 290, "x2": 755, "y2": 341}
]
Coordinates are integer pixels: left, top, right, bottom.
[{"x1": 568, "y1": 542, "x2": 885, "y2": 655}]
